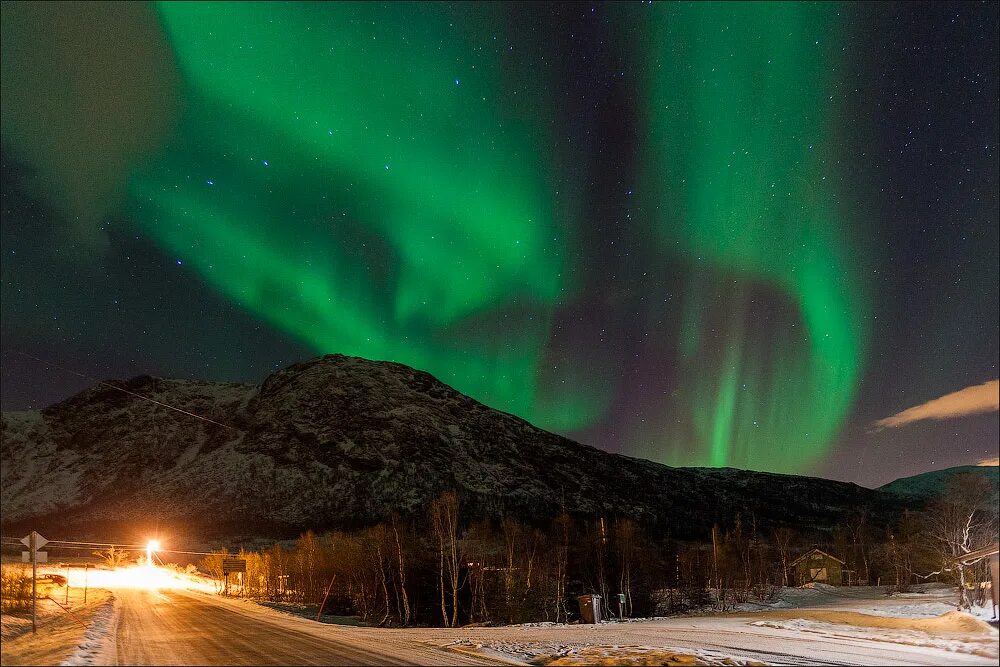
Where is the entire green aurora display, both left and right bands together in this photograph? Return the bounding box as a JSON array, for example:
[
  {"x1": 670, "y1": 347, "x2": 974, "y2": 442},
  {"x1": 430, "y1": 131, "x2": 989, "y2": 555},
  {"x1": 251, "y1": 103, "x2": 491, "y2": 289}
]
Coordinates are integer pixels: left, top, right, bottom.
[{"x1": 121, "y1": 3, "x2": 868, "y2": 472}]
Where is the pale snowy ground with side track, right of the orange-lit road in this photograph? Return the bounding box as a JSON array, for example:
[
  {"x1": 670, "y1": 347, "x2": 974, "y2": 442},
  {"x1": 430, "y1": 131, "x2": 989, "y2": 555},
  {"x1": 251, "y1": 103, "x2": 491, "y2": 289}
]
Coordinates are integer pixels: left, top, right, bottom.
[{"x1": 229, "y1": 584, "x2": 998, "y2": 665}]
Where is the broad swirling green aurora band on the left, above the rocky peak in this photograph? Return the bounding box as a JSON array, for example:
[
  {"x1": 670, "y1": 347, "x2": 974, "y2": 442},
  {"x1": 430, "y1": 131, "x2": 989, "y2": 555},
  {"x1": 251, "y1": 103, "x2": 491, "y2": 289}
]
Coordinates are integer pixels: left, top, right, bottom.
[{"x1": 131, "y1": 3, "x2": 603, "y2": 430}]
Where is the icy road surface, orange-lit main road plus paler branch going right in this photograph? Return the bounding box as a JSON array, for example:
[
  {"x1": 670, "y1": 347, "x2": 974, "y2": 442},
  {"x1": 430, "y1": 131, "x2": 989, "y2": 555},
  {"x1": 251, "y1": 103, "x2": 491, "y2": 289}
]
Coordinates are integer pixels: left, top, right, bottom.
[{"x1": 105, "y1": 590, "x2": 997, "y2": 665}]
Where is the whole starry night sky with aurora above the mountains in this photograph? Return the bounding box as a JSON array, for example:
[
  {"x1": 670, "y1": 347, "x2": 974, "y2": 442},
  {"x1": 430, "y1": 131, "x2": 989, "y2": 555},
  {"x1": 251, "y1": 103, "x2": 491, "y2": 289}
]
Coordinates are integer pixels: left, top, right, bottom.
[{"x1": 0, "y1": 2, "x2": 1000, "y2": 485}]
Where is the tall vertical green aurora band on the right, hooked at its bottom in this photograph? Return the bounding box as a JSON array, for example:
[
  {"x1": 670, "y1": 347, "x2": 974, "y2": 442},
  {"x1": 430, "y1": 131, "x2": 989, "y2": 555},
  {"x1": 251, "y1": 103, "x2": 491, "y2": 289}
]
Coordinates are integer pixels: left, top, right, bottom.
[{"x1": 644, "y1": 3, "x2": 870, "y2": 471}]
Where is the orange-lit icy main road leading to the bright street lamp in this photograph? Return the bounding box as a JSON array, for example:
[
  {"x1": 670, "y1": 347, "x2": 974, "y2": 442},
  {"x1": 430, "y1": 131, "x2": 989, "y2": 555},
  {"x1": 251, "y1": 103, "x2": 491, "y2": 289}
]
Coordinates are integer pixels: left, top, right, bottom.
[{"x1": 114, "y1": 590, "x2": 496, "y2": 665}]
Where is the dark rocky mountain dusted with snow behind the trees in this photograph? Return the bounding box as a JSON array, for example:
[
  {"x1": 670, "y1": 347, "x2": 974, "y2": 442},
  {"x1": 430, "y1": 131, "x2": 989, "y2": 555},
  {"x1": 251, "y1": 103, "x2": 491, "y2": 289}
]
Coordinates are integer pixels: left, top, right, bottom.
[{"x1": 0, "y1": 355, "x2": 900, "y2": 536}]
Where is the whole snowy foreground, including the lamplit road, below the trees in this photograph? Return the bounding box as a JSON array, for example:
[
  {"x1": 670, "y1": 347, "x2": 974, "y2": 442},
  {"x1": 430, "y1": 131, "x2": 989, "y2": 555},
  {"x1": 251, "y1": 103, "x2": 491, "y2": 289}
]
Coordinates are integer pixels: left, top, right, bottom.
[{"x1": 3, "y1": 571, "x2": 1000, "y2": 665}]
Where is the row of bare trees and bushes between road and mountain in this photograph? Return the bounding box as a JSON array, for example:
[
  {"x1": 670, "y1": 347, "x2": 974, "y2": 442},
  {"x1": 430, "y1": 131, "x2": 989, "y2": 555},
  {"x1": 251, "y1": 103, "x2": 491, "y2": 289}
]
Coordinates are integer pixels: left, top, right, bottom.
[{"x1": 200, "y1": 475, "x2": 997, "y2": 627}]
